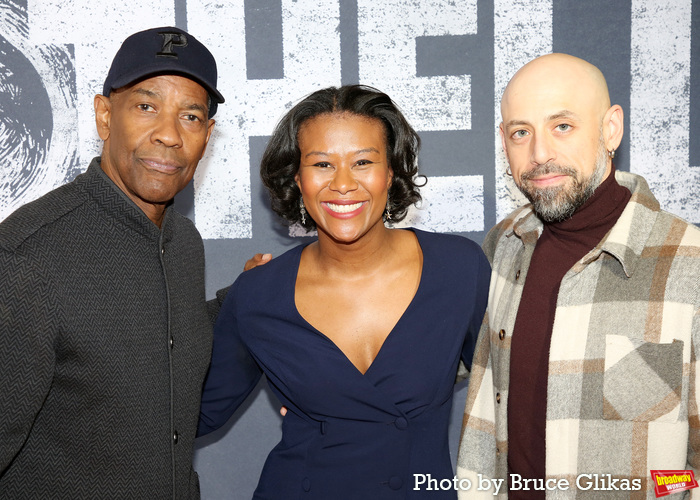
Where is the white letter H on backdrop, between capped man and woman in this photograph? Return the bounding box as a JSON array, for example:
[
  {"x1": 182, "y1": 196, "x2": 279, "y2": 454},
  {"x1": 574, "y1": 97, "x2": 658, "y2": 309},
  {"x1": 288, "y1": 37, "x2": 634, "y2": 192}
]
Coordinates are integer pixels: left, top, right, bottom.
[{"x1": 187, "y1": 0, "x2": 340, "y2": 239}]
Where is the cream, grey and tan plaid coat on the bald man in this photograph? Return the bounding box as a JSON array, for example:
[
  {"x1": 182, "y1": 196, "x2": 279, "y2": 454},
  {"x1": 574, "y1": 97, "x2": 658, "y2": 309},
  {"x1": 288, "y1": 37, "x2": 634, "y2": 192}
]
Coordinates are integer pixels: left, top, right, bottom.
[{"x1": 457, "y1": 171, "x2": 700, "y2": 500}]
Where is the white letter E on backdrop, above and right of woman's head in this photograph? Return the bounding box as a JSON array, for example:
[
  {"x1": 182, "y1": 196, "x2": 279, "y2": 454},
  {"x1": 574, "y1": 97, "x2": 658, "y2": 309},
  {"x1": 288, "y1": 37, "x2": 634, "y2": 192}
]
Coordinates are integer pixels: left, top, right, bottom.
[{"x1": 357, "y1": 0, "x2": 484, "y2": 231}]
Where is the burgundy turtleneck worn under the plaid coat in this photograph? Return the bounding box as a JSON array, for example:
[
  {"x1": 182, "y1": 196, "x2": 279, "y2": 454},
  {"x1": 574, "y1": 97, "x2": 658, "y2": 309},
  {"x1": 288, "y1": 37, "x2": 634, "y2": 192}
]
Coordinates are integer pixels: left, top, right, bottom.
[{"x1": 508, "y1": 167, "x2": 632, "y2": 499}]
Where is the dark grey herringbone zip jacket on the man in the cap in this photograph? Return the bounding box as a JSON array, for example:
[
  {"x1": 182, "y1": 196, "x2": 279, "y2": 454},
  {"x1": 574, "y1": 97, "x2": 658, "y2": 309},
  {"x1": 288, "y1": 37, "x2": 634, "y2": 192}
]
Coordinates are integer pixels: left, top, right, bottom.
[{"x1": 0, "y1": 158, "x2": 211, "y2": 500}]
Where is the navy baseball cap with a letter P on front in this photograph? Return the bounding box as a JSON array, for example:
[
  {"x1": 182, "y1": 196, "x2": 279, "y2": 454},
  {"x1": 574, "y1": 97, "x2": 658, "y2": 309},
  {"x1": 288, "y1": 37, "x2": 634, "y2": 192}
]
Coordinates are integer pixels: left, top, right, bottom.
[{"x1": 102, "y1": 26, "x2": 224, "y2": 118}]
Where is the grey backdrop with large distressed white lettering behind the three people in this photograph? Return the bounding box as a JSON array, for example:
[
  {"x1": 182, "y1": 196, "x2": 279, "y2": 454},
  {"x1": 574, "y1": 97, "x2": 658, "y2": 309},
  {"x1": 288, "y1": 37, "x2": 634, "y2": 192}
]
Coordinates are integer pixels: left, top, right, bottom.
[{"x1": 0, "y1": 0, "x2": 700, "y2": 499}]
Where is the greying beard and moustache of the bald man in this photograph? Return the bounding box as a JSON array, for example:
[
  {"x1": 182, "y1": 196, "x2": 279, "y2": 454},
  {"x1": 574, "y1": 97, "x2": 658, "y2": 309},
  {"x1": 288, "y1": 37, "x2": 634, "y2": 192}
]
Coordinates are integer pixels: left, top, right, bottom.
[{"x1": 518, "y1": 137, "x2": 607, "y2": 222}]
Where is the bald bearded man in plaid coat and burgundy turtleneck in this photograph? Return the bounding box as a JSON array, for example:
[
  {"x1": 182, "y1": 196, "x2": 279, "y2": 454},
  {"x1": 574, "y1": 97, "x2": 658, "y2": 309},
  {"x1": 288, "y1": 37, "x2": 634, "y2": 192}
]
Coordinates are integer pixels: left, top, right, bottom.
[{"x1": 456, "y1": 54, "x2": 700, "y2": 499}]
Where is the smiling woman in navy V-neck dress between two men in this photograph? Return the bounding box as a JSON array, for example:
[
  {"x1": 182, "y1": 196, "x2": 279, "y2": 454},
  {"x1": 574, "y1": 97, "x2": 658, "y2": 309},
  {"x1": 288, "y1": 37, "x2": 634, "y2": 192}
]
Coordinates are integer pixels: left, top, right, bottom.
[{"x1": 199, "y1": 86, "x2": 490, "y2": 500}]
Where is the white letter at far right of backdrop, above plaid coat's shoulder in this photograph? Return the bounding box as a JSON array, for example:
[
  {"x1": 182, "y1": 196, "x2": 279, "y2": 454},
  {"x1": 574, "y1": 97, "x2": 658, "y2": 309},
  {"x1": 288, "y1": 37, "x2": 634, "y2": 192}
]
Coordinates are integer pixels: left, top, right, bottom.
[{"x1": 630, "y1": 0, "x2": 700, "y2": 222}]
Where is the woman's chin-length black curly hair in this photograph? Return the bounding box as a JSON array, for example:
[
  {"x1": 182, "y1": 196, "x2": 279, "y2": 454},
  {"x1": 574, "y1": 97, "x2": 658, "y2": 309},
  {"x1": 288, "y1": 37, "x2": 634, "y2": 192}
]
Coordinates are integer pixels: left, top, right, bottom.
[{"x1": 260, "y1": 85, "x2": 421, "y2": 230}]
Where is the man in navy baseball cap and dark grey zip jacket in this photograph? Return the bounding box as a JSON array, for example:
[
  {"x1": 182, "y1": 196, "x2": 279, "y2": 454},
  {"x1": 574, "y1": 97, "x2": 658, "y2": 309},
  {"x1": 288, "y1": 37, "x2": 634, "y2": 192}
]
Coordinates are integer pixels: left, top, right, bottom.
[{"x1": 0, "y1": 27, "x2": 224, "y2": 500}]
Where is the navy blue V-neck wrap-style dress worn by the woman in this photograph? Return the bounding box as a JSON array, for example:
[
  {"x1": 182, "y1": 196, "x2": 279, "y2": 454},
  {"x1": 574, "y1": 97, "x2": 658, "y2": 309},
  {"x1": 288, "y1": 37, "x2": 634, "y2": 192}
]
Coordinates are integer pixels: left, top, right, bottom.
[{"x1": 199, "y1": 230, "x2": 490, "y2": 500}]
